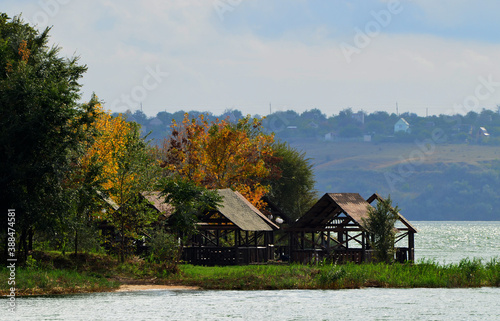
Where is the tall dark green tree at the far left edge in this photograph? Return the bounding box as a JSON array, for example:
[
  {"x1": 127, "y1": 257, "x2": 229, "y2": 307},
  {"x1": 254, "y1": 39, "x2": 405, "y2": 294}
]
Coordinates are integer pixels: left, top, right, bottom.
[{"x1": 0, "y1": 13, "x2": 91, "y2": 262}]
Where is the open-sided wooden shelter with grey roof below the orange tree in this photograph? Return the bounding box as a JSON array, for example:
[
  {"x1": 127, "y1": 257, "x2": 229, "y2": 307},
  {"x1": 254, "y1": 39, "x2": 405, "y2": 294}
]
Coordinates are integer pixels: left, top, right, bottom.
[{"x1": 183, "y1": 189, "x2": 279, "y2": 265}]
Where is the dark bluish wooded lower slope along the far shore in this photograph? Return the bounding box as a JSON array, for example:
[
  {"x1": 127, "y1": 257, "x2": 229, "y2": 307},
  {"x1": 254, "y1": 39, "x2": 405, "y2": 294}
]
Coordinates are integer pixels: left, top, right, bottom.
[{"x1": 318, "y1": 161, "x2": 500, "y2": 221}]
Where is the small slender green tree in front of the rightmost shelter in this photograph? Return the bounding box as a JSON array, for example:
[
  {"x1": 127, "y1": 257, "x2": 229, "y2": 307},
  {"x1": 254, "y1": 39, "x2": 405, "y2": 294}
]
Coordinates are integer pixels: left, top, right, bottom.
[{"x1": 364, "y1": 196, "x2": 399, "y2": 263}]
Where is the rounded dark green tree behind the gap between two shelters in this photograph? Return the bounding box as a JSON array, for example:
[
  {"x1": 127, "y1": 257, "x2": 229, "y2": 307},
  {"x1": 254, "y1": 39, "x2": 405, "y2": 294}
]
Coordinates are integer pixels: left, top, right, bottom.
[{"x1": 269, "y1": 142, "x2": 317, "y2": 219}]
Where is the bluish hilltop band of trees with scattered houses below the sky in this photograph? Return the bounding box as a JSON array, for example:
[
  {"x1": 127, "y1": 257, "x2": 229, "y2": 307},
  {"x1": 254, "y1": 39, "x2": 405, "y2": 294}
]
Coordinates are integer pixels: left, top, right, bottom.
[{"x1": 116, "y1": 108, "x2": 500, "y2": 145}]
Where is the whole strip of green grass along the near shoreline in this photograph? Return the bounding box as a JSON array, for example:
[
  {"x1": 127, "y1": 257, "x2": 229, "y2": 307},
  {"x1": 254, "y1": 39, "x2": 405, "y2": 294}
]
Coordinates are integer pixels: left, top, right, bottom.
[{"x1": 0, "y1": 253, "x2": 500, "y2": 295}]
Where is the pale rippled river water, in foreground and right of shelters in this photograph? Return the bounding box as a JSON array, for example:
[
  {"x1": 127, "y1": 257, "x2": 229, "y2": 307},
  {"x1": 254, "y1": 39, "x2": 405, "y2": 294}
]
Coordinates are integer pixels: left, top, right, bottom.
[{"x1": 0, "y1": 222, "x2": 500, "y2": 321}]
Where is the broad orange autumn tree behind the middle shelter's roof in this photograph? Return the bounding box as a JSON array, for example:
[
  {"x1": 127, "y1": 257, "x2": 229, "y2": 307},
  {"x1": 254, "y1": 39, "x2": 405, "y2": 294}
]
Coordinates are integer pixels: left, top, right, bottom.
[{"x1": 162, "y1": 114, "x2": 274, "y2": 207}]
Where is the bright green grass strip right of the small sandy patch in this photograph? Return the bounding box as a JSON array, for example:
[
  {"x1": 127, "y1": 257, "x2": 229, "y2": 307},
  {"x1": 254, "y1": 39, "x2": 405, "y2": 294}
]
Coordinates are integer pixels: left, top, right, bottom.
[{"x1": 173, "y1": 259, "x2": 500, "y2": 290}]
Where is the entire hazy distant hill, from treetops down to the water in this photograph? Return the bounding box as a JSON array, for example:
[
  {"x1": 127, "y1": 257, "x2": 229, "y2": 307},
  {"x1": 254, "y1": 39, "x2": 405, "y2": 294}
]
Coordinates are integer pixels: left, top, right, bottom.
[{"x1": 125, "y1": 109, "x2": 500, "y2": 220}]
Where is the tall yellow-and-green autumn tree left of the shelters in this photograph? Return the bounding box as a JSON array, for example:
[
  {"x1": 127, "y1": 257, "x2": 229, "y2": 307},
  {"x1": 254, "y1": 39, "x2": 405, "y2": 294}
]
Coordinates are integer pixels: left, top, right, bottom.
[{"x1": 81, "y1": 106, "x2": 160, "y2": 261}]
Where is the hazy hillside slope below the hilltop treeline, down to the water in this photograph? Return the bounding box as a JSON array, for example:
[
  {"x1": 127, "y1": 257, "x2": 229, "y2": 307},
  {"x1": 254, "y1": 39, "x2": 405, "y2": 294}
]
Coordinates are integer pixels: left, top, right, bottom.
[{"x1": 291, "y1": 139, "x2": 500, "y2": 220}]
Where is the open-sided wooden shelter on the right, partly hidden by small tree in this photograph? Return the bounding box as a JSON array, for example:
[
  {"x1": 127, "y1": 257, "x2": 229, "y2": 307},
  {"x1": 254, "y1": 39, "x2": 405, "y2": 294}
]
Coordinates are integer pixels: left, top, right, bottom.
[{"x1": 287, "y1": 193, "x2": 417, "y2": 263}]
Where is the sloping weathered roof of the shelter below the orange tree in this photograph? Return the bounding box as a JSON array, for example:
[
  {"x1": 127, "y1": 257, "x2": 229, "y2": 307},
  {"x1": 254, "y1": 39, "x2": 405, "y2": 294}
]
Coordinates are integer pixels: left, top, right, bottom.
[{"x1": 217, "y1": 188, "x2": 279, "y2": 231}]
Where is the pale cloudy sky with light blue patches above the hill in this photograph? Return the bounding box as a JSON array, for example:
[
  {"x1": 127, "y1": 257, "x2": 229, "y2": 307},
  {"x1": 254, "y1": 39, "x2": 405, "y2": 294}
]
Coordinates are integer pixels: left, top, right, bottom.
[{"x1": 0, "y1": 0, "x2": 500, "y2": 116}]
